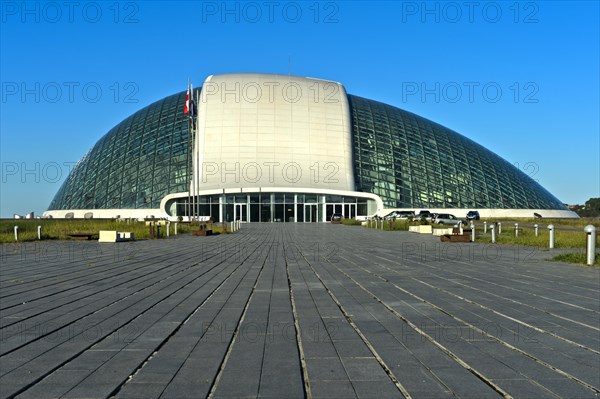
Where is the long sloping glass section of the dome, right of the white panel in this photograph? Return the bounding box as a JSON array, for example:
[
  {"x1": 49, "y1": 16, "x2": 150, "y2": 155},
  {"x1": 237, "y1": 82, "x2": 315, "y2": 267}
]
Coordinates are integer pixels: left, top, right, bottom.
[{"x1": 348, "y1": 95, "x2": 567, "y2": 209}]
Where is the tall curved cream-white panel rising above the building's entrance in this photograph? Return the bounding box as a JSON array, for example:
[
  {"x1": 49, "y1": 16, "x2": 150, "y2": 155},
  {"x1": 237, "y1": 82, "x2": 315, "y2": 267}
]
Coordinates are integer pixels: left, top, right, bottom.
[{"x1": 194, "y1": 74, "x2": 354, "y2": 191}]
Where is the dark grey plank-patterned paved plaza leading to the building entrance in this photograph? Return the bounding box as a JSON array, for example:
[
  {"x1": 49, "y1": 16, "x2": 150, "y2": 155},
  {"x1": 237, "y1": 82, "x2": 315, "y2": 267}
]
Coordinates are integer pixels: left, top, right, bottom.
[{"x1": 0, "y1": 224, "x2": 600, "y2": 399}]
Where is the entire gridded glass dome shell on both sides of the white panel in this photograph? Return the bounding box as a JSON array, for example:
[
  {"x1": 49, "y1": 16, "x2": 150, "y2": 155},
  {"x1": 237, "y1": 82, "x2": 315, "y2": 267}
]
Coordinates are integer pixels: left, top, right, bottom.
[{"x1": 49, "y1": 91, "x2": 566, "y2": 210}]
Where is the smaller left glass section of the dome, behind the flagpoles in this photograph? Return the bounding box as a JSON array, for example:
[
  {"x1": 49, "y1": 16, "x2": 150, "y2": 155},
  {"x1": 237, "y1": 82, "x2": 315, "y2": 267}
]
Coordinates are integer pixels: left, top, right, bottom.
[{"x1": 49, "y1": 92, "x2": 191, "y2": 210}]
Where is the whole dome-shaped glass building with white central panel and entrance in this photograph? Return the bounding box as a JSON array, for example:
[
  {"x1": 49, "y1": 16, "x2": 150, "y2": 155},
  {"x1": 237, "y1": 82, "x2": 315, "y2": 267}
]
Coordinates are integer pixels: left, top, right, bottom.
[{"x1": 45, "y1": 74, "x2": 577, "y2": 222}]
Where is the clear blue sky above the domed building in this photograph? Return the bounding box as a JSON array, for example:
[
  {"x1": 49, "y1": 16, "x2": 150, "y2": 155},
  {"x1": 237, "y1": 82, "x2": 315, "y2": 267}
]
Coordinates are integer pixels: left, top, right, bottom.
[{"x1": 0, "y1": 1, "x2": 600, "y2": 217}]
